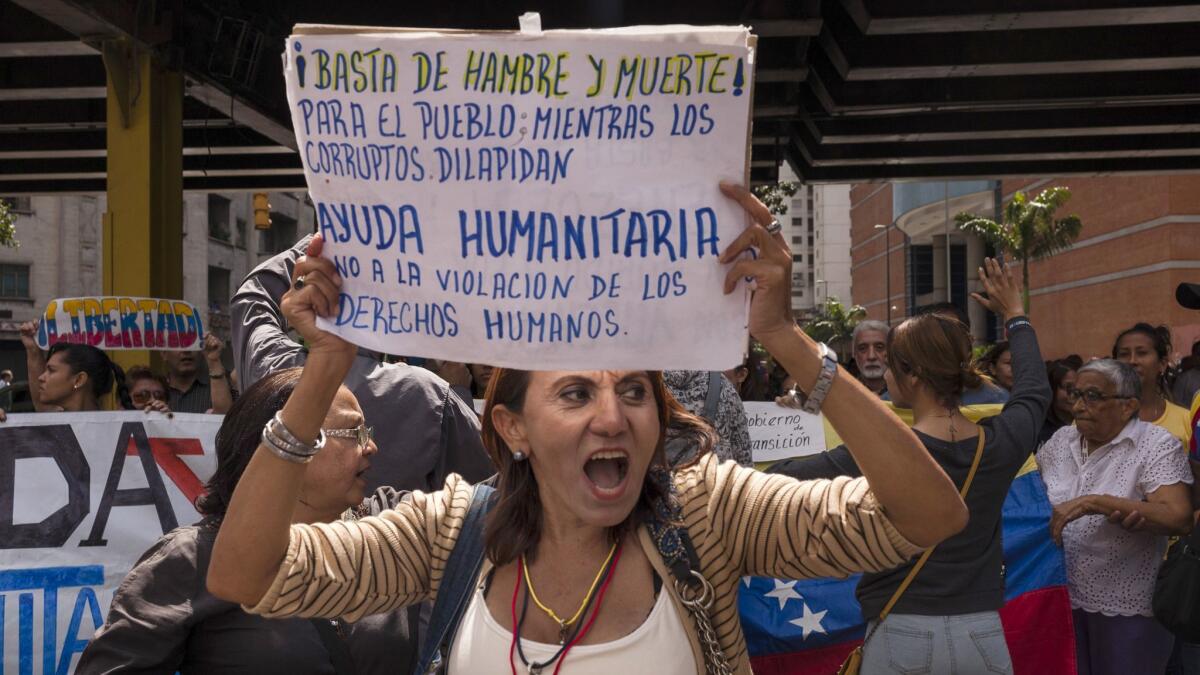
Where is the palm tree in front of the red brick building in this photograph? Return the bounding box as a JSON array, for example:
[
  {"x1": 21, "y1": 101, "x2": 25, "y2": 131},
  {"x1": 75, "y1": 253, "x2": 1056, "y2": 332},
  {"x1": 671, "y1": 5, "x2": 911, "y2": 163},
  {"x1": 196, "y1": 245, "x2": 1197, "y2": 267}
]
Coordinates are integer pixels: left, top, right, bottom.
[{"x1": 954, "y1": 187, "x2": 1084, "y2": 313}]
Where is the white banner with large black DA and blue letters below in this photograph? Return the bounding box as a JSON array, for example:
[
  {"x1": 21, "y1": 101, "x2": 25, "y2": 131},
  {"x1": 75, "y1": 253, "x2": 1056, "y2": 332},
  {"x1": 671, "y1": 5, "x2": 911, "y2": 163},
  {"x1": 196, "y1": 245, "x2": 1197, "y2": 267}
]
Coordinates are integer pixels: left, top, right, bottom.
[{"x1": 0, "y1": 412, "x2": 222, "y2": 675}]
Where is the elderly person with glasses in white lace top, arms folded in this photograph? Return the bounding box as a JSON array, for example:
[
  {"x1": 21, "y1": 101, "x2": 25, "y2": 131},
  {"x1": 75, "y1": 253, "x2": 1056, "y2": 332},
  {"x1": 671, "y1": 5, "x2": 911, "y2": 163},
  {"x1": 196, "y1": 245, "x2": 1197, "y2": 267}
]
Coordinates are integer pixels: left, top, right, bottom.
[{"x1": 1038, "y1": 359, "x2": 1193, "y2": 675}]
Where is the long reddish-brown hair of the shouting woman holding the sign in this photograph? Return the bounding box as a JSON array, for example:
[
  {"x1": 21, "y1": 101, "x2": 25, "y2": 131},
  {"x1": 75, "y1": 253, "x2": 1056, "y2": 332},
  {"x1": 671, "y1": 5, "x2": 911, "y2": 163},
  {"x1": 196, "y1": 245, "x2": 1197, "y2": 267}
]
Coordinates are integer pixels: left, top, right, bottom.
[{"x1": 481, "y1": 368, "x2": 716, "y2": 566}]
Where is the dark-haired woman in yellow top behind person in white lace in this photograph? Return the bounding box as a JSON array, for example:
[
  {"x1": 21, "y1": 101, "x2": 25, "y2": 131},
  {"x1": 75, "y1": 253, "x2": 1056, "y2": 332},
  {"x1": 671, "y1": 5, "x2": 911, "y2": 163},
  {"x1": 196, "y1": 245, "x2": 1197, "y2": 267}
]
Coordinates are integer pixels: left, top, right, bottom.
[{"x1": 1112, "y1": 323, "x2": 1192, "y2": 448}]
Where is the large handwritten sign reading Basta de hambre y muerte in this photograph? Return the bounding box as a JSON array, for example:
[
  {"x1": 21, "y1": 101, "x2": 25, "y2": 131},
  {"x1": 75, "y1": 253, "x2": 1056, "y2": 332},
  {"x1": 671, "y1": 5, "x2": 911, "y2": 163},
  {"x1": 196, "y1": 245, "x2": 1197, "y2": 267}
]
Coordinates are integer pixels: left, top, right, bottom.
[{"x1": 284, "y1": 26, "x2": 754, "y2": 370}]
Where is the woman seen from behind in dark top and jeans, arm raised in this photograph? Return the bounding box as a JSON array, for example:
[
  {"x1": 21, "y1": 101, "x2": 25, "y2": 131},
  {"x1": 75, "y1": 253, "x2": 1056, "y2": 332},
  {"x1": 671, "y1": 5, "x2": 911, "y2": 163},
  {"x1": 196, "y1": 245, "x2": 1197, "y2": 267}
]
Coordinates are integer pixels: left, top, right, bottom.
[{"x1": 770, "y1": 259, "x2": 1050, "y2": 673}]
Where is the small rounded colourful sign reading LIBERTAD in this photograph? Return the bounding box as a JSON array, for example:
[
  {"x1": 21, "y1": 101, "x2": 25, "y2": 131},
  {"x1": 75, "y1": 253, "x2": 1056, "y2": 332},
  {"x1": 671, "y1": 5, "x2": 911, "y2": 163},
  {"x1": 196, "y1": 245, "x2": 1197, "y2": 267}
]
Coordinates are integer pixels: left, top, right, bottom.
[{"x1": 37, "y1": 295, "x2": 204, "y2": 352}]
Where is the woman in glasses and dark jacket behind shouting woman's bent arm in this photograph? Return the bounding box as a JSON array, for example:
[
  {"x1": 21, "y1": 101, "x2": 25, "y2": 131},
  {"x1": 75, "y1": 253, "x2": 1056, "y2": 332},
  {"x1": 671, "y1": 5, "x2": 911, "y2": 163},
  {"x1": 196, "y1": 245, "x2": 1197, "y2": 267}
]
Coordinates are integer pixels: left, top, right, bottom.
[{"x1": 76, "y1": 368, "x2": 419, "y2": 675}]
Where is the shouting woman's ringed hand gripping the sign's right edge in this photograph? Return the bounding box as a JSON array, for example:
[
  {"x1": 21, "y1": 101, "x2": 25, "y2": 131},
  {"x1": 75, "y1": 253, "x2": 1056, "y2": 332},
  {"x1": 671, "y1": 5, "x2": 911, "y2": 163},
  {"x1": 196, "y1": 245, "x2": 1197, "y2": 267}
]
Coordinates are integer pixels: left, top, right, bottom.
[{"x1": 720, "y1": 183, "x2": 794, "y2": 340}]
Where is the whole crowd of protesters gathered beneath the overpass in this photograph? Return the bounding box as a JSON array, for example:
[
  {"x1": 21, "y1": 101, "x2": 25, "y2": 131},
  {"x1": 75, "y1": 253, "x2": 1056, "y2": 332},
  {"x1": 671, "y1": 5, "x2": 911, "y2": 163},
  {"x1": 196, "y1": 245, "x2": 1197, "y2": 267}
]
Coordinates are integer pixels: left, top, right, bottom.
[{"x1": 0, "y1": 186, "x2": 1200, "y2": 674}]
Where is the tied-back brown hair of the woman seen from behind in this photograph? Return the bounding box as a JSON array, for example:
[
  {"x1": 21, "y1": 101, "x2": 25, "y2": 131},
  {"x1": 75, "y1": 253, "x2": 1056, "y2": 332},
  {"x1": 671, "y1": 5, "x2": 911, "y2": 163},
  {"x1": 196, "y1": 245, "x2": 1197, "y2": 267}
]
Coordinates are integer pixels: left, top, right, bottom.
[{"x1": 888, "y1": 313, "x2": 983, "y2": 407}]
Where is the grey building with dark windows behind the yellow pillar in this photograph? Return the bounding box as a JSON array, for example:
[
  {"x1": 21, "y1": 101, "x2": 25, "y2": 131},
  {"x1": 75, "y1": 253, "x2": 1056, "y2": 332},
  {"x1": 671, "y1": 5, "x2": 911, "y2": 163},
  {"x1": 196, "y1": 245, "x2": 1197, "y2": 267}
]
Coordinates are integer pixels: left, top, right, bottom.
[{"x1": 0, "y1": 192, "x2": 314, "y2": 381}]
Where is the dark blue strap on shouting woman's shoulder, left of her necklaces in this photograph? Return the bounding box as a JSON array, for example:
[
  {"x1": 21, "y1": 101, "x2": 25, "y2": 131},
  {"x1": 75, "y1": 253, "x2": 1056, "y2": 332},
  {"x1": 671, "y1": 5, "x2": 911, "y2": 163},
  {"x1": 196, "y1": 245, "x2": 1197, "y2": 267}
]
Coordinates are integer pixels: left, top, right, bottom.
[{"x1": 415, "y1": 484, "x2": 496, "y2": 675}]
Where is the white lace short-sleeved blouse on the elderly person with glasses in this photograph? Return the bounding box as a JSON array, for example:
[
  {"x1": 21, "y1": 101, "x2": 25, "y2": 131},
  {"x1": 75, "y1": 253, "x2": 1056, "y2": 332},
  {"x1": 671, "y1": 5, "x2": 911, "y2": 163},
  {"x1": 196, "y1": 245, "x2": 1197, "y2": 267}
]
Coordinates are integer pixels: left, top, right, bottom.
[{"x1": 1038, "y1": 418, "x2": 1192, "y2": 616}]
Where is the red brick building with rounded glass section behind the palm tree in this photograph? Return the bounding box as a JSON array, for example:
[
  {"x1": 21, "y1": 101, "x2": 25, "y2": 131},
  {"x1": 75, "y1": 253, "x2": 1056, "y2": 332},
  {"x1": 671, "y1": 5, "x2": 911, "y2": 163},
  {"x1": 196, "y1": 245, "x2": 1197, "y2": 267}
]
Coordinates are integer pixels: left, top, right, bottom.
[{"x1": 851, "y1": 175, "x2": 1200, "y2": 358}]
